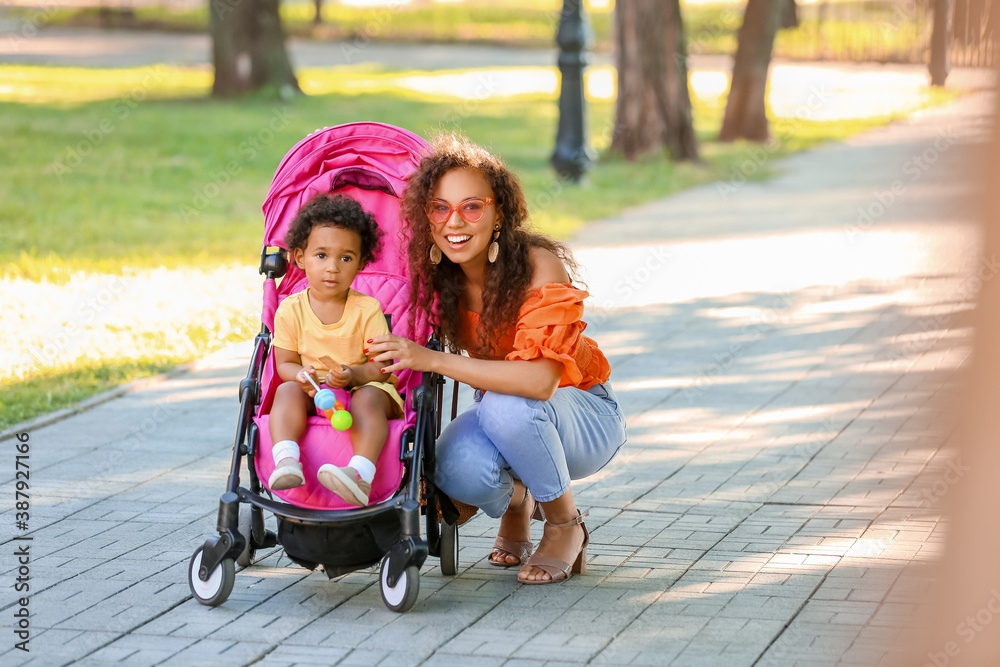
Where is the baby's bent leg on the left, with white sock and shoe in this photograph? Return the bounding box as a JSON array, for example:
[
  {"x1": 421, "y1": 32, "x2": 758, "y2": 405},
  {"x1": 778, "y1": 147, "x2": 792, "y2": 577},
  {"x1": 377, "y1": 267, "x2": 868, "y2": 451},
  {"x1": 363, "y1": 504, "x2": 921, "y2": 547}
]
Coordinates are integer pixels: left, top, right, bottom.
[{"x1": 267, "y1": 382, "x2": 312, "y2": 491}]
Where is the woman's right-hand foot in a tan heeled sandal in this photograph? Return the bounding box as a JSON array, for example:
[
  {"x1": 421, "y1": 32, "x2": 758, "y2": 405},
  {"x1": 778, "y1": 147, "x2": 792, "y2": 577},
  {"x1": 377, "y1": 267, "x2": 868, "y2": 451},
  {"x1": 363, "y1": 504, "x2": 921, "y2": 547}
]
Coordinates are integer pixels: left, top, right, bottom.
[{"x1": 517, "y1": 501, "x2": 590, "y2": 584}]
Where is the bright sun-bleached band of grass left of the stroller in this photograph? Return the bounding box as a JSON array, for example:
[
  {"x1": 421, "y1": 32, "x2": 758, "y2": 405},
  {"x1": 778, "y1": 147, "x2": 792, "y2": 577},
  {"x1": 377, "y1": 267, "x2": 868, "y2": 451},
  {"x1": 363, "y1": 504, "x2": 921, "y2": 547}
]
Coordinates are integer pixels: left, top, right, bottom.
[{"x1": 0, "y1": 264, "x2": 261, "y2": 384}]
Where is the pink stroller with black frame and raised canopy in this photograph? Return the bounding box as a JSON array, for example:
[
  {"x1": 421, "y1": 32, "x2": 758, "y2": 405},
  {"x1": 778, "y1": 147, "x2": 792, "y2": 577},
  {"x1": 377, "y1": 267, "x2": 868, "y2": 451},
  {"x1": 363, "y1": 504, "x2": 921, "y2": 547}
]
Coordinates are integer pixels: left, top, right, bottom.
[{"x1": 188, "y1": 123, "x2": 458, "y2": 612}]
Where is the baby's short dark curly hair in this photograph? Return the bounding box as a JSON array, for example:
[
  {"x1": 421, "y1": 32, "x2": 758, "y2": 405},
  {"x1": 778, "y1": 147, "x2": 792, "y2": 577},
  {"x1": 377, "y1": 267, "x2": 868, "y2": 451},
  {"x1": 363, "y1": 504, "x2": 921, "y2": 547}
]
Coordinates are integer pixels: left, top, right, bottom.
[{"x1": 285, "y1": 194, "x2": 385, "y2": 266}]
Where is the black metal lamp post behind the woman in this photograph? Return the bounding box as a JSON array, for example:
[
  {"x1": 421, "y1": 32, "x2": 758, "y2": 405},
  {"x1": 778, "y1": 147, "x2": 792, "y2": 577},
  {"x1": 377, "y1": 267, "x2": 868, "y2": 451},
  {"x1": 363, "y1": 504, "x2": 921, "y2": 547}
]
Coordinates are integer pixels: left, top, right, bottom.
[{"x1": 551, "y1": 0, "x2": 597, "y2": 182}]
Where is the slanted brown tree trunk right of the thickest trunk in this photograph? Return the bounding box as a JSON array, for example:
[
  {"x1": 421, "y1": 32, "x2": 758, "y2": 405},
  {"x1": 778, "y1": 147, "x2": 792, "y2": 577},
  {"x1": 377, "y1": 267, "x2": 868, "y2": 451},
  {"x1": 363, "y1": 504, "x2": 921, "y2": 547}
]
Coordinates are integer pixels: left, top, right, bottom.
[{"x1": 719, "y1": 0, "x2": 784, "y2": 142}]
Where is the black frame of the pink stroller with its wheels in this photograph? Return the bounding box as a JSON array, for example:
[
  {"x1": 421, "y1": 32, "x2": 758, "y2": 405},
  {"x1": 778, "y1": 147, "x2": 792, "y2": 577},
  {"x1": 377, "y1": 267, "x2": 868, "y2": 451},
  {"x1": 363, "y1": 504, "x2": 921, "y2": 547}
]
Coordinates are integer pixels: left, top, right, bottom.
[{"x1": 188, "y1": 252, "x2": 459, "y2": 612}]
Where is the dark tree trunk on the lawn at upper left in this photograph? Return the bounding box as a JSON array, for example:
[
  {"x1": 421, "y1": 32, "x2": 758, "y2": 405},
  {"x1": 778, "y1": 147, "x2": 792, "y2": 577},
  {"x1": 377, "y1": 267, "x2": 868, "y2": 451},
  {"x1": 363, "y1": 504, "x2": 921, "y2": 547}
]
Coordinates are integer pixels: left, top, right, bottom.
[{"x1": 209, "y1": 0, "x2": 302, "y2": 98}]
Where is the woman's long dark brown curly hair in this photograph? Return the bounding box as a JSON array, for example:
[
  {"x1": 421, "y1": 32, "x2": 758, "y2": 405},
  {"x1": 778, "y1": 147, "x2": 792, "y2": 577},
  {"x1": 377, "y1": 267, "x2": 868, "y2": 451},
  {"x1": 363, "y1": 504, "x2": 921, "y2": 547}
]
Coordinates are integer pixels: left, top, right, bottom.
[{"x1": 401, "y1": 133, "x2": 577, "y2": 357}]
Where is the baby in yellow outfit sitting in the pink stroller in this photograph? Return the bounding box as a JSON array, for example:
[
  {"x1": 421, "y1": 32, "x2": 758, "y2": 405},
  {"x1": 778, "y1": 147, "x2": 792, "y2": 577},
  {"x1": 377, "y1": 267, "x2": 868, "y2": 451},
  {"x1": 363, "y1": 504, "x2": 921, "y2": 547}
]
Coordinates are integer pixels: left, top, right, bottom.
[{"x1": 268, "y1": 195, "x2": 403, "y2": 507}]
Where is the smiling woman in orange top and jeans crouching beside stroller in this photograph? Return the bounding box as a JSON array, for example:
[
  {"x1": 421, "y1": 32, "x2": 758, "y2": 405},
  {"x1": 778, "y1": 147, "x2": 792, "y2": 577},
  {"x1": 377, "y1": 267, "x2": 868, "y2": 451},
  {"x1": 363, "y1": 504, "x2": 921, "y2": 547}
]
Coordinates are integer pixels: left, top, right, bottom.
[{"x1": 368, "y1": 135, "x2": 626, "y2": 584}]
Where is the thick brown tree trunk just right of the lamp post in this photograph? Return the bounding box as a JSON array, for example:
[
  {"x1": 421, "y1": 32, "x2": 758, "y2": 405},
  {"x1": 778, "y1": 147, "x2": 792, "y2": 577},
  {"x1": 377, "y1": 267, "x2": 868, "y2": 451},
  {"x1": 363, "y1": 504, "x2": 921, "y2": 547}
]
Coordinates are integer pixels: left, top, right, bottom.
[{"x1": 611, "y1": 0, "x2": 698, "y2": 160}]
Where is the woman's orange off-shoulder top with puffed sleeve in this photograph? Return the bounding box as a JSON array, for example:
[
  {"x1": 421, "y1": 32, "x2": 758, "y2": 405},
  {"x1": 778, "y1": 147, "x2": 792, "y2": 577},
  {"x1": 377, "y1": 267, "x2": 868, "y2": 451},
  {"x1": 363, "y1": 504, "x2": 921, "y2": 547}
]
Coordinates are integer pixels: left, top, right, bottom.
[{"x1": 459, "y1": 283, "x2": 611, "y2": 389}]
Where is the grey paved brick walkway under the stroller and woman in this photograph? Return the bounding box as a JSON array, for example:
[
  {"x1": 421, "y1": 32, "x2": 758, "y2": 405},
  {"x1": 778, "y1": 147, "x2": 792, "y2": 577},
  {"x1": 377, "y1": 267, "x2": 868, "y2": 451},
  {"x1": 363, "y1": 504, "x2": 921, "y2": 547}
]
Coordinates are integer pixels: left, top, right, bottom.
[{"x1": 0, "y1": 56, "x2": 996, "y2": 667}]
